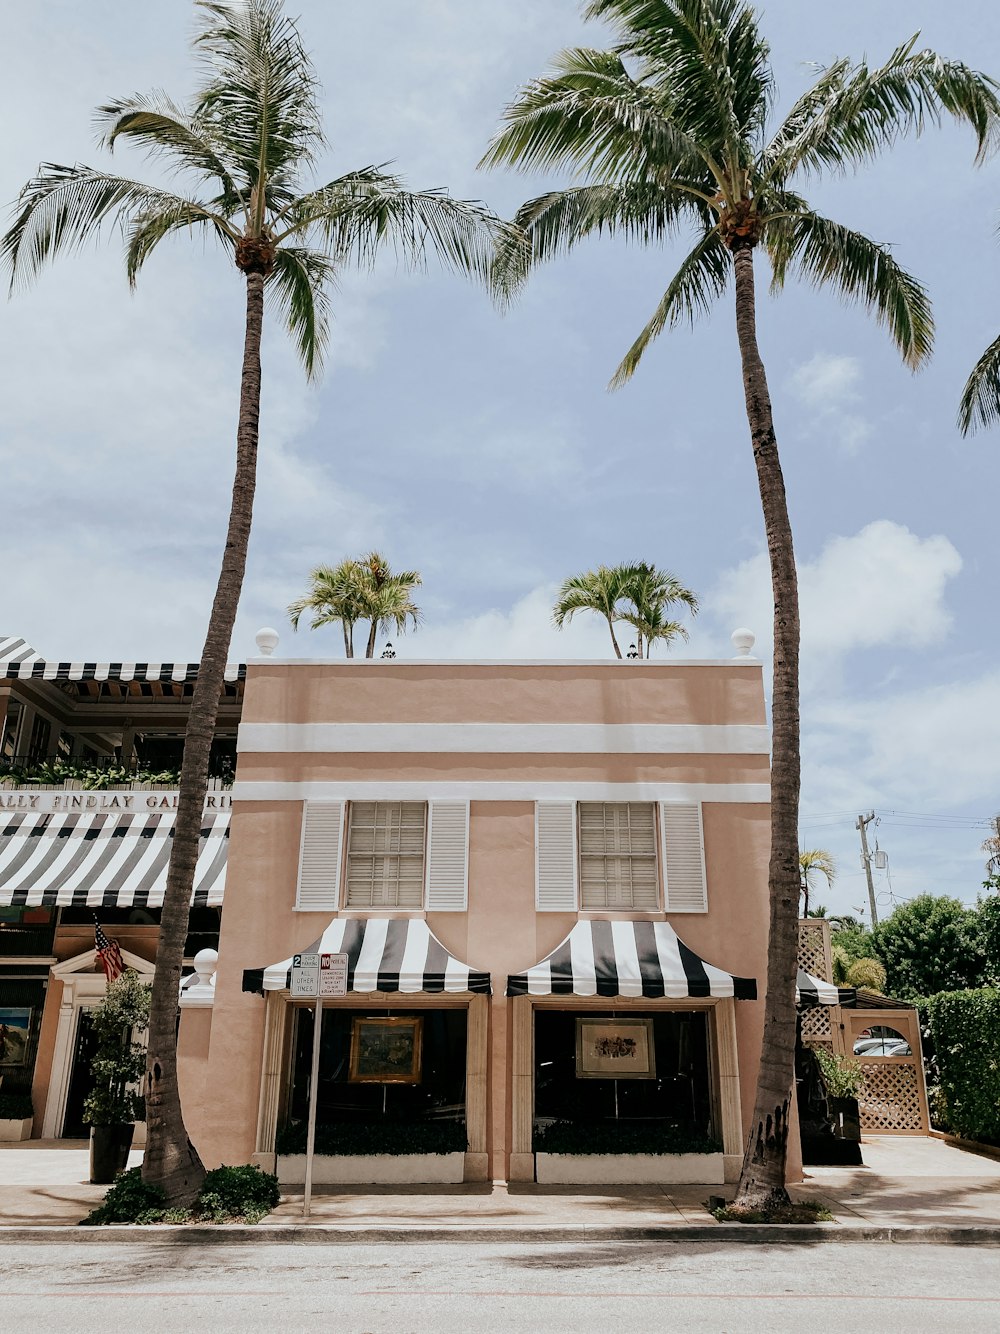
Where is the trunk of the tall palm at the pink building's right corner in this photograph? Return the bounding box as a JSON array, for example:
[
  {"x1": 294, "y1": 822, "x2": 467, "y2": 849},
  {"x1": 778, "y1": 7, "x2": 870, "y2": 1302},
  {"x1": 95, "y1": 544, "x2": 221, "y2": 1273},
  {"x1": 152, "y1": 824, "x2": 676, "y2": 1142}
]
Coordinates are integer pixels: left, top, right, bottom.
[{"x1": 732, "y1": 237, "x2": 800, "y2": 1209}]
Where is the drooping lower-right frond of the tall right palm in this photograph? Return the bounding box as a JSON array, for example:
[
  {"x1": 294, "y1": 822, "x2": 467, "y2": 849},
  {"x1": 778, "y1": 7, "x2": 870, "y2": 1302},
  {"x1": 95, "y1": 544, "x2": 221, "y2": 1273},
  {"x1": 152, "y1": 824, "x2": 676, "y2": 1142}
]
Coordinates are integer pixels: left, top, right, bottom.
[{"x1": 764, "y1": 212, "x2": 933, "y2": 370}]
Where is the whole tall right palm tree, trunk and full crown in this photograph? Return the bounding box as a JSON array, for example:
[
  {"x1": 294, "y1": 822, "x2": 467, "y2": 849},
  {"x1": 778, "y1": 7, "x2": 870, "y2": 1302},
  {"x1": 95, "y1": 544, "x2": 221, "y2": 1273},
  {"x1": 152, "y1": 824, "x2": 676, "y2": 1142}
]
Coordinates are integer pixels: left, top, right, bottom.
[{"x1": 484, "y1": 0, "x2": 1000, "y2": 1209}]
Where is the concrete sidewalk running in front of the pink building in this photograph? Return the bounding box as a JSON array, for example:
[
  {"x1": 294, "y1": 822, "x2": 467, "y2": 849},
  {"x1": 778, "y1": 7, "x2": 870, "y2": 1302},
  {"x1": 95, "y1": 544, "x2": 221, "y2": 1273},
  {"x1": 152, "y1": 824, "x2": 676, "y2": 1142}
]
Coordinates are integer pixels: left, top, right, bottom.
[{"x1": 0, "y1": 1135, "x2": 1000, "y2": 1243}]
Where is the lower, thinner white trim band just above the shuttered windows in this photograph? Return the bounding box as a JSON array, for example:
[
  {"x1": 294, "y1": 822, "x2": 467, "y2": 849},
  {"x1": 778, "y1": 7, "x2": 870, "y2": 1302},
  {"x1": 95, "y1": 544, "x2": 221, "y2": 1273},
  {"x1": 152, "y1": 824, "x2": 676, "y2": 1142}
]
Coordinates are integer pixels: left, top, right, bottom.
[{"x1": 232, "y1": 780, "x2": 771, "y2": 803}]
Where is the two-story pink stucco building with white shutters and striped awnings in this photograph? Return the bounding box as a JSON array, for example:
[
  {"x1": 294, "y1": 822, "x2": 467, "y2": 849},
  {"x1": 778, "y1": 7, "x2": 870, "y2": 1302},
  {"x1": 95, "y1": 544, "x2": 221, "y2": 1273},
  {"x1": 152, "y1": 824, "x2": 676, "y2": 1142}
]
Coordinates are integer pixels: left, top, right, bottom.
[{"x1": 180, "y1": 655, "x2": 769, "y2": 1182}]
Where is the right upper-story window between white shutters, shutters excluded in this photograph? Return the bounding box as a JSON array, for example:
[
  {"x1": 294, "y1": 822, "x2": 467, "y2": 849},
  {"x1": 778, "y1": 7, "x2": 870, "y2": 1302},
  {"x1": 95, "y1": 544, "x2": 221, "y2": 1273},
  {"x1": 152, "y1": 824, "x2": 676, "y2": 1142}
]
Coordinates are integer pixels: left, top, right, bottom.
[{"x1": 579, "y1": 802, "x2": 660, "y2": 910}]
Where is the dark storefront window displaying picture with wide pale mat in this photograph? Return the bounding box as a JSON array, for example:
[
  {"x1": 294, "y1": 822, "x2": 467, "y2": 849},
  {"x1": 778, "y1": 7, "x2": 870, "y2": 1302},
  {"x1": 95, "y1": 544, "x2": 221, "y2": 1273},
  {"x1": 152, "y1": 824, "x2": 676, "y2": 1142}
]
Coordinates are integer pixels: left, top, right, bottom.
[{"x1": 535, "y1": 1010, "x2": 713, "y2": 1138}]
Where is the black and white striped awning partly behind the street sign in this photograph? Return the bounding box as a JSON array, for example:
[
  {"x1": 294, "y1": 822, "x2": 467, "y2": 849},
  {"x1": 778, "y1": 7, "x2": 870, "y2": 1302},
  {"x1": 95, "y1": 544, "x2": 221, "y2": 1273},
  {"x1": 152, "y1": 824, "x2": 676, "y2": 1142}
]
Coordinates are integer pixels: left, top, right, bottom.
[{"x1": 243, "y1": 918, "x2": 489, "y2": 995}]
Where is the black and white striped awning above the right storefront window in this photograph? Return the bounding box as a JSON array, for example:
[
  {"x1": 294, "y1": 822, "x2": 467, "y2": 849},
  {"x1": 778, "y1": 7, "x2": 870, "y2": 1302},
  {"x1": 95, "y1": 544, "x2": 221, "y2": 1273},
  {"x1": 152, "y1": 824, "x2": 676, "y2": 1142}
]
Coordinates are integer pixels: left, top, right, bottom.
[{"x1": 507, "y1": 922, "x2": 757, "y2": 1001}]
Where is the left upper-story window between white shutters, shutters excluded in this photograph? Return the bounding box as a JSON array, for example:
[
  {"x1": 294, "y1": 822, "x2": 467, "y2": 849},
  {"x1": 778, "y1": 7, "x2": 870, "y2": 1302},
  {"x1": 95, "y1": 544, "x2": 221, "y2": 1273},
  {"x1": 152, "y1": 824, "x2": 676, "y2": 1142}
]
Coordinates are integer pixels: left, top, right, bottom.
[{"x1": 345, "y1": 802, "x2": 427, "y2": 908}]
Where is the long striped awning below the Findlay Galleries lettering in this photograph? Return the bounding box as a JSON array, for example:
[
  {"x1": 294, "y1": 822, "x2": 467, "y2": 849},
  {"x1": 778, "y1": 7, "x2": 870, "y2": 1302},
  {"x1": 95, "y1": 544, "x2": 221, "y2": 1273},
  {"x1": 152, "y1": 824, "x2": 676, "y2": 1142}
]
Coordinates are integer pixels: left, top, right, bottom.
[{"x1": 0, "y1": 811, "x2": 229, "y2": 907}]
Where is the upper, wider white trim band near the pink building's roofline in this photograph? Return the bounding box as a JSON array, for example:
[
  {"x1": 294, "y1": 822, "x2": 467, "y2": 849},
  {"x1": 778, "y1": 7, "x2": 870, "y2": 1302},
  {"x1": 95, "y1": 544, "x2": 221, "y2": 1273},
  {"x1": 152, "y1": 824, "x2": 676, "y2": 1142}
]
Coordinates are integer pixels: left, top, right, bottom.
[{"x1": 236, "y1": 723, "x2": 771, "y2": 755}]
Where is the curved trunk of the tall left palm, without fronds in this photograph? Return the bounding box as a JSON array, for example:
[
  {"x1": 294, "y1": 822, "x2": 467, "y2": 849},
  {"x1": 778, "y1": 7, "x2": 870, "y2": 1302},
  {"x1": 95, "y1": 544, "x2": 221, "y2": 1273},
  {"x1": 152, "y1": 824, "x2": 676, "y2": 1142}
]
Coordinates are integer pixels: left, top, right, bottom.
[{"x1": 143, "y1": 272, "x2": 264, "y2": 1206}]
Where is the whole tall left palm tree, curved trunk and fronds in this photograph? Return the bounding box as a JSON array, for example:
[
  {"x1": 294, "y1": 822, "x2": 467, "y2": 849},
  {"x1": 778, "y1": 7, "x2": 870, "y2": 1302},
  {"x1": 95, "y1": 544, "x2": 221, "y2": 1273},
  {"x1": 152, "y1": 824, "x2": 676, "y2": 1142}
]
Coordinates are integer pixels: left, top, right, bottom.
[{"x1": 0, "y1": 0, "x2": 512, "y2": 1205}]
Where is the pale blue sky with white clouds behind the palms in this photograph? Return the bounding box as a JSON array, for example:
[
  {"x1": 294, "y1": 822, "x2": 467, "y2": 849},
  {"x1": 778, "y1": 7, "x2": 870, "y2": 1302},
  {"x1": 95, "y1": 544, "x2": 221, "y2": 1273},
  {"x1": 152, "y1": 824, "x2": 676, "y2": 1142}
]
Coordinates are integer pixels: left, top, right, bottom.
[{"x1": 0, "y1": 0, "x2": 1000, "y2": 911}]
